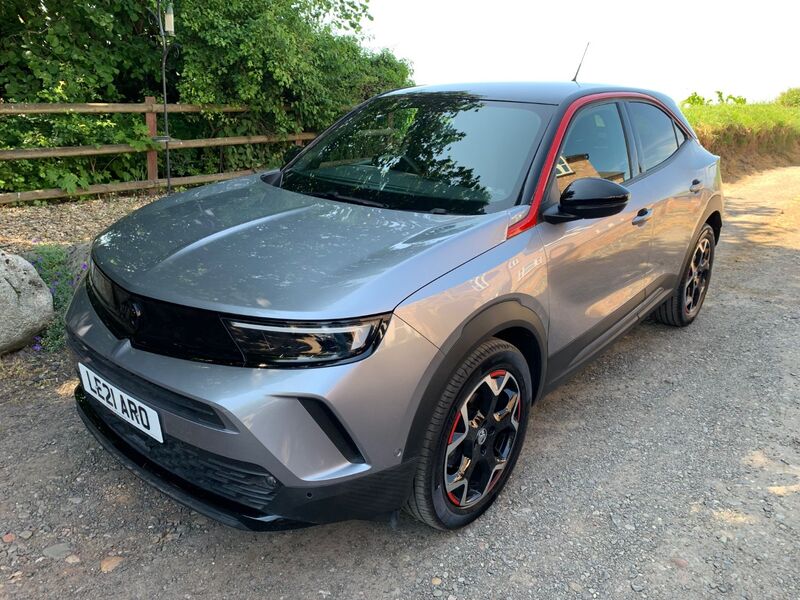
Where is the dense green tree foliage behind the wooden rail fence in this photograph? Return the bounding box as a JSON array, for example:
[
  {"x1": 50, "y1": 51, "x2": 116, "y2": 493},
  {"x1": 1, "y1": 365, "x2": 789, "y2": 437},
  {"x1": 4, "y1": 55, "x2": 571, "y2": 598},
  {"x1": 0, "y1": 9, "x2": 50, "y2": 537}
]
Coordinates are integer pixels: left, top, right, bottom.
[{"x1": 0, "y1": 0, "x2": 410, "y2": 191}]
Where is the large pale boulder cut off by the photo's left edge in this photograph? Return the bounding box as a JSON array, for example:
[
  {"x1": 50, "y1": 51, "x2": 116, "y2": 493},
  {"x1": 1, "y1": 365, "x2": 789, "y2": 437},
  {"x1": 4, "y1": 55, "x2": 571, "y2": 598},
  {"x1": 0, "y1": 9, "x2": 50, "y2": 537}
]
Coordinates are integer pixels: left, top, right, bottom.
[{"x1": 0, "y1": 250, "x2": 53, "y2": 354}]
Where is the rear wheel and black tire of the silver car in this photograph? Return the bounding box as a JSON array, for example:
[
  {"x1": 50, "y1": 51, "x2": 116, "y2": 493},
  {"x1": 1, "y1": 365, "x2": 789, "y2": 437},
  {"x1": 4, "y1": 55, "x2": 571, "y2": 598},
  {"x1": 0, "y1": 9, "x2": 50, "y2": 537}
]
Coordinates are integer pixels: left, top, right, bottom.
[{"x1": 653, "y1": 223, "x2": 716, "y2": 327}]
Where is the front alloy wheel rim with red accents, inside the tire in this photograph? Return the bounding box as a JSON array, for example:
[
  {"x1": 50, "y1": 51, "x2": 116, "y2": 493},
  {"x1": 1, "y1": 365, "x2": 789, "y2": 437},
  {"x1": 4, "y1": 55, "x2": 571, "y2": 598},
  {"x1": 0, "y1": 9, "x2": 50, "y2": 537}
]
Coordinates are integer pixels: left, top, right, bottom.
[{"x1": 443, "y1": 369, "x2": 522, "y2": 508}]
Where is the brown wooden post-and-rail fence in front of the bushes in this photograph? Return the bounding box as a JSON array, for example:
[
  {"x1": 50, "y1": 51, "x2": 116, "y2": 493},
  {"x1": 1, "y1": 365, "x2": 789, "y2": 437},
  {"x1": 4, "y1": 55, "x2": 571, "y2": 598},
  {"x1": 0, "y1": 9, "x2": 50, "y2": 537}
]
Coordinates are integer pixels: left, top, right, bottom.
[{"x1": 0, "y1": 96, "x2": 316, "y2": 204}]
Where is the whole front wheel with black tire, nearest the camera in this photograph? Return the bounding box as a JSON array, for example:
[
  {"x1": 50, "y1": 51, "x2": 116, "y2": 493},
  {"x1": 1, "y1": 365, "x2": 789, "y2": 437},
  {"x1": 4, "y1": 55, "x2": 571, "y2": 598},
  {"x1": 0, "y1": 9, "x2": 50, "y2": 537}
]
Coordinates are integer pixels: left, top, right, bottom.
[{"x1": 405, "y1": 338, "x2": 533, "y2": 529}]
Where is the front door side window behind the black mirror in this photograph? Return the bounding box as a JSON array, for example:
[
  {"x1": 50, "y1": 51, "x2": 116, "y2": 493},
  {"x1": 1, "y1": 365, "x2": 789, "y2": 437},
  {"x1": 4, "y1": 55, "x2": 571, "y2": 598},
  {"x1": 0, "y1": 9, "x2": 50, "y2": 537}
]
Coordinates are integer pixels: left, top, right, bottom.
[{"x1": 555, "y1": 104, "x2": 628, "y2": 194}]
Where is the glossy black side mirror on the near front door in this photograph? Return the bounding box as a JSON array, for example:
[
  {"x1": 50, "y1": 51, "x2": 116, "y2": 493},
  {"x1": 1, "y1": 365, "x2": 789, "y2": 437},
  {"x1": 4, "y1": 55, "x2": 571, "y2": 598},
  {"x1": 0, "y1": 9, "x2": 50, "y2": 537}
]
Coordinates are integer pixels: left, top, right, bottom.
[{"x1": 544, "y1": 177, "x2": 631, "y2": 223}]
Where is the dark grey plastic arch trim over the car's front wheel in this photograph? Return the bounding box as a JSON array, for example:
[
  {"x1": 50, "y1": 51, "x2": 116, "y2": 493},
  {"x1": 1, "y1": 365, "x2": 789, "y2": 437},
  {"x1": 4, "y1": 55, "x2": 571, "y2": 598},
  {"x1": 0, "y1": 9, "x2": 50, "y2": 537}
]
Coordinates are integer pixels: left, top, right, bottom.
[{"x1": 403, "y1": 298, "x2": 547, "y2": 460}]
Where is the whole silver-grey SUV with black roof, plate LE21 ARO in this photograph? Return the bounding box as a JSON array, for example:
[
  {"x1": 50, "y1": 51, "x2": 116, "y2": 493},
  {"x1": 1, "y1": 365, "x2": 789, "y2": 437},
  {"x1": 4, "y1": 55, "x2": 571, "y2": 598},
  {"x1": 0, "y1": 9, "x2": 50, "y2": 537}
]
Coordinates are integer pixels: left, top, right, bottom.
[{"x1": 67, "y1": 83, "x2": 723, "y2": 529}]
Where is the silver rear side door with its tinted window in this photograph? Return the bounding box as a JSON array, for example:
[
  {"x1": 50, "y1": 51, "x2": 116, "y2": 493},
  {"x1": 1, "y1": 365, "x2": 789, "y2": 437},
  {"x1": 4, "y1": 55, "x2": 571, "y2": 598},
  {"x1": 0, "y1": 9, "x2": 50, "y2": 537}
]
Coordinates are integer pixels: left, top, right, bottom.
[{"x1": 626, "y1": 100, "x2": 707, "y2": 293}]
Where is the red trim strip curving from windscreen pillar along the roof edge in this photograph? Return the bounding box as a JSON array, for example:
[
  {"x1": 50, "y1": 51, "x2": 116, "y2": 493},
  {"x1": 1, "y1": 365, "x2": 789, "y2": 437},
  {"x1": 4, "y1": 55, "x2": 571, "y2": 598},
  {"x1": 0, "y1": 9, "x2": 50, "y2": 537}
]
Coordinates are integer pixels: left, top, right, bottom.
[{"x1": 506, "y1": 92, "x2": 695, "y2": 238}]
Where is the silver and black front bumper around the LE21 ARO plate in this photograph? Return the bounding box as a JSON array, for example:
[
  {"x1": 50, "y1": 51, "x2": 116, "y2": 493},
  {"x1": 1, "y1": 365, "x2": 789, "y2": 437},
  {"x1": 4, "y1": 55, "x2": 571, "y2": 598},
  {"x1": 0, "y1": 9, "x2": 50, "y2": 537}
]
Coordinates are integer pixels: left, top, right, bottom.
[{"x1": 67, "y1": 282, "x2": 437, "y2": 530}]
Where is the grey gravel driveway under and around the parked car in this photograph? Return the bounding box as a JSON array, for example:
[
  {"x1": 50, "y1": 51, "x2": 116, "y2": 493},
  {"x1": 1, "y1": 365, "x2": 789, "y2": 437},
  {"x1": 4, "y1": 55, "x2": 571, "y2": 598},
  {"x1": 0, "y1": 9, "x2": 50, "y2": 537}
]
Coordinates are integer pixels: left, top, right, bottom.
[{"x1": 0, "y1": 168, "x2": 800, "y2": 600}]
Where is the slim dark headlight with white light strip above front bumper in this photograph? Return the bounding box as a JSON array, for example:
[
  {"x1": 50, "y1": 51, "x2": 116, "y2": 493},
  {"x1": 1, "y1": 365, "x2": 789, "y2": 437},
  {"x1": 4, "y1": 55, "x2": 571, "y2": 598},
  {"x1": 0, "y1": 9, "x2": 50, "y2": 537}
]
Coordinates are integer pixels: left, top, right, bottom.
[{"x1": 224, "y1": 315, "x2": 389, "y2": 367}]
